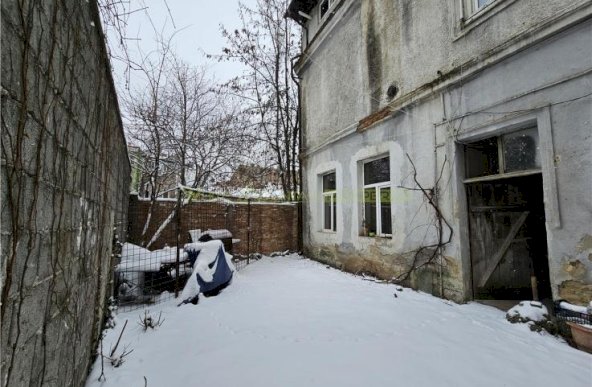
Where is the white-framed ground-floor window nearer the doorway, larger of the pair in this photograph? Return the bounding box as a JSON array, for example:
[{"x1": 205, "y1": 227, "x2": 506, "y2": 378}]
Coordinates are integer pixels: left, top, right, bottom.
[{"x1": 362, "y1": 157, "x2": 392, "y2": 236}]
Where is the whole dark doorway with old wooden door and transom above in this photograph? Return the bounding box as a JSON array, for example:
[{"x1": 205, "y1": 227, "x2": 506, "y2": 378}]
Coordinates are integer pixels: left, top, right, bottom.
[{"x1": 464, "y1": 128, "x2": 551, "y2": 300}]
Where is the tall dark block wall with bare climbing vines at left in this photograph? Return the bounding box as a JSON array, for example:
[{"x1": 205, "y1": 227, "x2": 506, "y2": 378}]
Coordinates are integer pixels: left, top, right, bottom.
[{"x1": 0, "y1": 1, "x2": 130, "y2": 387}]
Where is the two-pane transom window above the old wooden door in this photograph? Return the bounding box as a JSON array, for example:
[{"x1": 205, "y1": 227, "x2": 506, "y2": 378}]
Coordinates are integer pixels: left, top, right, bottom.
[{"x1": 465, "y1": 128, "x2": 541, "y2": 178}]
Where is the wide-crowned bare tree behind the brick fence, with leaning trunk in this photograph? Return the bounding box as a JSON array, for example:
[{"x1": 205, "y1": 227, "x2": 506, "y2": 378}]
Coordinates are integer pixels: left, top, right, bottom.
[{"x1": 123, "y1": 37, "x2": 254, "y2": 239}]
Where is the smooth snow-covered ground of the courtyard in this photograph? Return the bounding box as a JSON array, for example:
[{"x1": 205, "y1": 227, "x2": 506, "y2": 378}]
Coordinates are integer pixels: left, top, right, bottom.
[{"x1": 87, "y1": 255, "x2": 592, "y2": 387}]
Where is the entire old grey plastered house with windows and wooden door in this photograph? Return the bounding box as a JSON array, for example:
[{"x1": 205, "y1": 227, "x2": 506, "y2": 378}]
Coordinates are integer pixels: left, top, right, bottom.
[{"x1": 287, "y1": 0, "x2": 592, "y2": 304}]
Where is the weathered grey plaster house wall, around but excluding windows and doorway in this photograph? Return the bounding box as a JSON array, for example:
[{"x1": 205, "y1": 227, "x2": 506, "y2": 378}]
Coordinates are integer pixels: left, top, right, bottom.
[{"x1": 299, "y1": 0, "x2": 592, "y2": 303}]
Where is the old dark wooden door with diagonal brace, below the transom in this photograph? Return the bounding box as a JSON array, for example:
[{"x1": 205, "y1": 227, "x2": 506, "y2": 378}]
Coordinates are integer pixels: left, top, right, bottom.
[{"x1": 467, "y1": 175, "x2": 548, "y2": 299}]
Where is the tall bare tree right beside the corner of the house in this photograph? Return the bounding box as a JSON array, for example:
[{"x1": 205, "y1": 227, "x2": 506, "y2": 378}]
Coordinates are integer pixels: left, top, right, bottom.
[{"x1": 218, "y1": 0, "x2": 300, "y2": 200}]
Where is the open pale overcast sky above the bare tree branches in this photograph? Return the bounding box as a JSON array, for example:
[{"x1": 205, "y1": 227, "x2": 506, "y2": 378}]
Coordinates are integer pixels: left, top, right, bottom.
[{"x1": 108, "y1": 0, "x2": 256, "y2": 89}]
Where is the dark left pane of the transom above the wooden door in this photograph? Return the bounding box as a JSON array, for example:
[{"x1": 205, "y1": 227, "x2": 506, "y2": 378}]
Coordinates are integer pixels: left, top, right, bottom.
[{"x1": 465, "y1": 137, "x2": 499, "y2": 177}]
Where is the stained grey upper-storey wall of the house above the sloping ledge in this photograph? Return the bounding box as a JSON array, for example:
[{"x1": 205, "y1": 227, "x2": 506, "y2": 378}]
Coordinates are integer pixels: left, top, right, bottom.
[{"x1": 298, "y1": 0, "x2": 592, "y2": 150}]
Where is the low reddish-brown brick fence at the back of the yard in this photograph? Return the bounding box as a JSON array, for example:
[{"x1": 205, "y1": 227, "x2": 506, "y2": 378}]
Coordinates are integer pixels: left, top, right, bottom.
[{"x1": 128, "y1": 195, "x2": 300, "y2": 255}]
